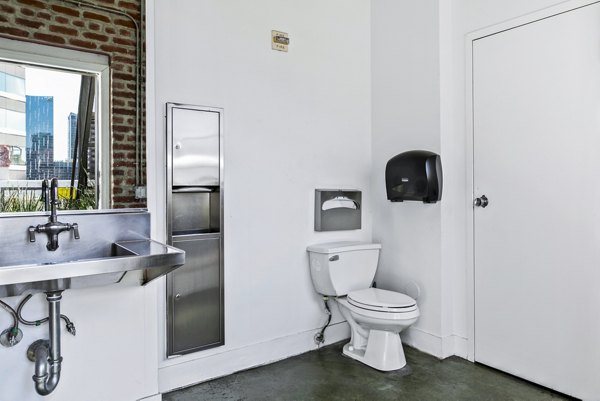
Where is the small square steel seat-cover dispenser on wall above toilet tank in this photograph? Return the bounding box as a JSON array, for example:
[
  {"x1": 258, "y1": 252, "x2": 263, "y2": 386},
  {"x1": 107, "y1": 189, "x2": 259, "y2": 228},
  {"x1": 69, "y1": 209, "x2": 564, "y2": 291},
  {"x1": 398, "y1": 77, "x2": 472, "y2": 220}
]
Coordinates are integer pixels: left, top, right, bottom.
[{"x1": 315, "y1": 189, "x2": 362, "y2": 231}]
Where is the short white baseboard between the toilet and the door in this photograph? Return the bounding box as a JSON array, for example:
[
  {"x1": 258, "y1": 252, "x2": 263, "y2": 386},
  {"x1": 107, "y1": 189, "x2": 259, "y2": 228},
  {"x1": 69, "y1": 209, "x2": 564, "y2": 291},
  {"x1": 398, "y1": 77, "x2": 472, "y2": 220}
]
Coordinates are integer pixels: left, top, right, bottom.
[{"x1": 402, "y1": 327, "x2": 468, "y2": 359}]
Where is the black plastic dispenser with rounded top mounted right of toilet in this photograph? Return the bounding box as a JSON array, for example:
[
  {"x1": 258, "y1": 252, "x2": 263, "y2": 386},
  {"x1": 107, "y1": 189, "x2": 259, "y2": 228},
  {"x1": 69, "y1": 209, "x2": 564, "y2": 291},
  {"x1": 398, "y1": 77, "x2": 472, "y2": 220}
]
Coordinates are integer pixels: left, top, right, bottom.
[{"x1": 385, "y1": 150, "x2": 443, "y2": 203}]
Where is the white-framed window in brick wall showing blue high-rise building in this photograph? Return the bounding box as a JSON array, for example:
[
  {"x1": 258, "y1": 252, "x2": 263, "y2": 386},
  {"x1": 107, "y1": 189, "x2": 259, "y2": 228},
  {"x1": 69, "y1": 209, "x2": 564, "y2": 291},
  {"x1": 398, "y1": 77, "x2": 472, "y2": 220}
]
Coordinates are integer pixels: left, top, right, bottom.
[{"x1": 0, "y1": 39, "x2": 110, "y2": 212}]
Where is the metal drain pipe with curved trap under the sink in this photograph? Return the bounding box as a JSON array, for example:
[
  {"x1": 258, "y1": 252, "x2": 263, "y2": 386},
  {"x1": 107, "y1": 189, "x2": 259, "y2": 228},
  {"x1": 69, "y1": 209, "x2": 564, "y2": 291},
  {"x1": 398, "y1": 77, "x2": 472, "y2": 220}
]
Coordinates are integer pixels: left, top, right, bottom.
[{"x1": 27, "y1": 291, "x2": 62, "y2": 395}]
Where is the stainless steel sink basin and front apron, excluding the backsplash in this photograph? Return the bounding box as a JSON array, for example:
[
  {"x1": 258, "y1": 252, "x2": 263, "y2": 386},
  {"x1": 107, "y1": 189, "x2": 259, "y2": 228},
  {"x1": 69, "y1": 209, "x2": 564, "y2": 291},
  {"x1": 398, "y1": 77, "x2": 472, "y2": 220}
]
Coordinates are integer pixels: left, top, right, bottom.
[{"x1": 0, "y1": 239, "x2": 185, "y2": 297}]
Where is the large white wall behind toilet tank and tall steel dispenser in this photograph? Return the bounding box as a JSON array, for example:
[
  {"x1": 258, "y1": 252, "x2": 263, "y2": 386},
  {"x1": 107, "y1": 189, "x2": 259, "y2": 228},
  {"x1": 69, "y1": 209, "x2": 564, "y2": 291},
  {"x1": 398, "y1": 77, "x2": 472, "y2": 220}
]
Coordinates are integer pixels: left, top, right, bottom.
[{"x1": 153, "y1": 0, "x2": 372, "y2": 391}]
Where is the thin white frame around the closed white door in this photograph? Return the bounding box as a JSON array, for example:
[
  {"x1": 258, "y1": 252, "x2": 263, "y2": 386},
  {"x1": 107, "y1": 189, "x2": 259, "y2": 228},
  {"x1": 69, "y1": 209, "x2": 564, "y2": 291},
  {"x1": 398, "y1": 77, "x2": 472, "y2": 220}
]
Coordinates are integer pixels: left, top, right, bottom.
[{"x1": 465, "y1": 0, "x2": 600, "y2": 362}]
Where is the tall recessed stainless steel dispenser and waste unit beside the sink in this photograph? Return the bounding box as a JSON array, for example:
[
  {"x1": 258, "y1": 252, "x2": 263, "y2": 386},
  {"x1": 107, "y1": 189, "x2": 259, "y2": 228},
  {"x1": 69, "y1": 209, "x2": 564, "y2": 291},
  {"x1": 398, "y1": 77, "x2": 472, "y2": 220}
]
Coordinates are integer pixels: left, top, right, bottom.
[{"x1": 166, "y1": 103, "x2": 225, "y2": 356}]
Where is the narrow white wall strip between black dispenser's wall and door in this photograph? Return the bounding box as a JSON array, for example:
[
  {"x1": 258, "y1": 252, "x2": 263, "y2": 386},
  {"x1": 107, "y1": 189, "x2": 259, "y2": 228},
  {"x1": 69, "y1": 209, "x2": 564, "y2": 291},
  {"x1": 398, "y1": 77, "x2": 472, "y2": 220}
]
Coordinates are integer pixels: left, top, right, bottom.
[{"x1": 440, "y1": 0, "x2": 575, "y2": 359}]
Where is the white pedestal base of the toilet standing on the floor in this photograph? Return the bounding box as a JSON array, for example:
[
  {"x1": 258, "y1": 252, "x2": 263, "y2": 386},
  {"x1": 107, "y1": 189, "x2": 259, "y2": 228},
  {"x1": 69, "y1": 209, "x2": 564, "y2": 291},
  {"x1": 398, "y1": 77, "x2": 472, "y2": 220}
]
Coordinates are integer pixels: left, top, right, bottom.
[{"x1": 343, "y1": 330, "x2": 406, "y2": 372}]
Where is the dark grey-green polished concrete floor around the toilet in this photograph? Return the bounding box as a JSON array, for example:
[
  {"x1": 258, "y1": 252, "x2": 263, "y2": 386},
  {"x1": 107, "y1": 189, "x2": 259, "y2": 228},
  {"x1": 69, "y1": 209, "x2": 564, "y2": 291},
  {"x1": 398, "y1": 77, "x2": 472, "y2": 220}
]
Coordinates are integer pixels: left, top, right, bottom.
[{"x1": 163, "y1": 343, "x2": 571, "y2": 401}]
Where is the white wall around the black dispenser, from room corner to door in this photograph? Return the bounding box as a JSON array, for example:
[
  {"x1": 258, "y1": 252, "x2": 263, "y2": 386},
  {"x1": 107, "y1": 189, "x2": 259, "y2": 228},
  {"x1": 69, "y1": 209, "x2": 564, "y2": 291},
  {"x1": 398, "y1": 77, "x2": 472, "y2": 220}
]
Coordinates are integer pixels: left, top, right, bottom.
[{"x1": 371, "y1": 0, "x2": 576, "y2": 357}]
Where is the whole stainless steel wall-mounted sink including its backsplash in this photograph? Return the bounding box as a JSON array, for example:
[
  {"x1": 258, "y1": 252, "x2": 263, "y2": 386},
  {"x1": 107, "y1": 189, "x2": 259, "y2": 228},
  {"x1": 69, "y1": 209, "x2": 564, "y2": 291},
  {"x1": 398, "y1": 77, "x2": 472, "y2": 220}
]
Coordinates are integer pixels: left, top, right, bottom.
[{"x1": 0, "y1": 211, "x2": 185, "y2": 297}]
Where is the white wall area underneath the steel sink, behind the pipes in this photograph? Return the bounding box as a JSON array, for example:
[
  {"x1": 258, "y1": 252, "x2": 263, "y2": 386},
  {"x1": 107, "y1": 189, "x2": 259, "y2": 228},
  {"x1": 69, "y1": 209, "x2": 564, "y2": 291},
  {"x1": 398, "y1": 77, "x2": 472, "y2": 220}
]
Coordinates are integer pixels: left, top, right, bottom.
[{"x1": 0, "y1": 274, "x2": 157, "y2": 401}]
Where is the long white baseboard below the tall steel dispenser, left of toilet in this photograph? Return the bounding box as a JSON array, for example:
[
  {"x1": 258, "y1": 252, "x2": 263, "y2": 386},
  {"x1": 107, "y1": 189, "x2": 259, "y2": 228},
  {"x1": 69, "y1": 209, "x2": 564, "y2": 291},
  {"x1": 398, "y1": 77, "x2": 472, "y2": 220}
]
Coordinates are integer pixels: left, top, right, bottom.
[{"x1": 159, "y1": 322, "x2": 350, "y2": 392}]
